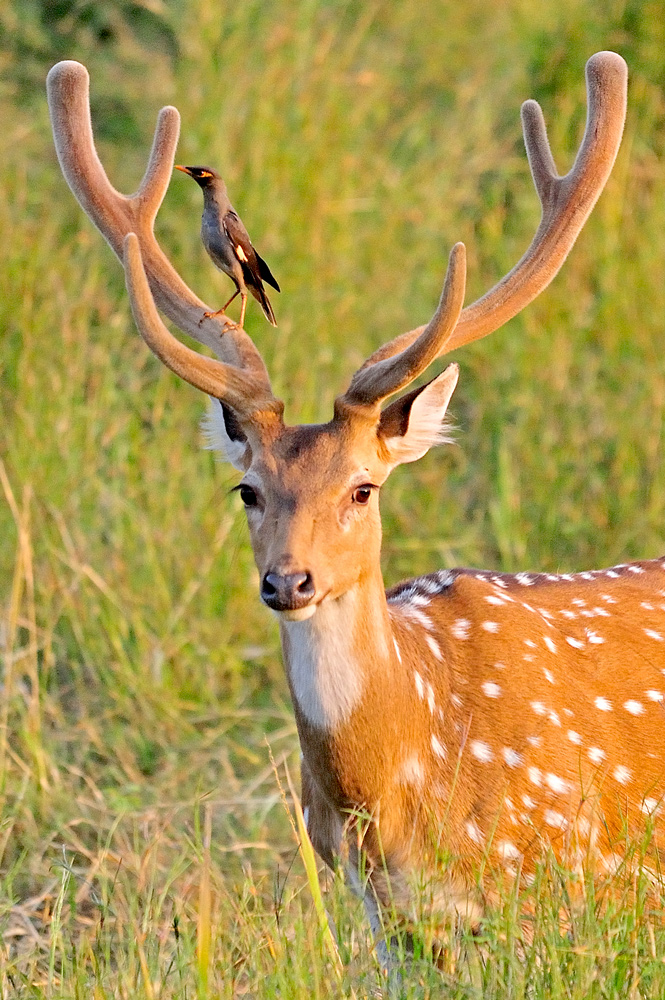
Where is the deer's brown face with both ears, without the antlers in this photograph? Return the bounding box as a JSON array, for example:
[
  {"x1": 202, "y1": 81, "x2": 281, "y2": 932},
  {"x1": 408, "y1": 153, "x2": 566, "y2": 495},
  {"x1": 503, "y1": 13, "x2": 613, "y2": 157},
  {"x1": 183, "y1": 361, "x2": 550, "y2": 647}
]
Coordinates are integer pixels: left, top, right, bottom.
[{"x1": 208, "y1": 365, "x2": 458, "y2": 620}]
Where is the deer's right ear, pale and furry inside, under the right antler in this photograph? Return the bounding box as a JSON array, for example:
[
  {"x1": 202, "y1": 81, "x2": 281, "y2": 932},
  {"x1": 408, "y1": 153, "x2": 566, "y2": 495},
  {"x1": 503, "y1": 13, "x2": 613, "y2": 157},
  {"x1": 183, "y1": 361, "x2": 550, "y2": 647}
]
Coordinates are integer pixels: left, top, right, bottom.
[{"x1": 378, "y1": 364, "x2": 459, "y2": 466}]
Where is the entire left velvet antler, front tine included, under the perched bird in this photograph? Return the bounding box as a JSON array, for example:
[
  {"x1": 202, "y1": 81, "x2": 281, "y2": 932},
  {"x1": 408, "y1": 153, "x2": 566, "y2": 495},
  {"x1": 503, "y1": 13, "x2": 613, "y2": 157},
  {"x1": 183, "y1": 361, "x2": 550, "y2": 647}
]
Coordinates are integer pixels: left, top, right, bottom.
[{"x1": 46, "y1": 60, "x2": 281, "y2": 412}]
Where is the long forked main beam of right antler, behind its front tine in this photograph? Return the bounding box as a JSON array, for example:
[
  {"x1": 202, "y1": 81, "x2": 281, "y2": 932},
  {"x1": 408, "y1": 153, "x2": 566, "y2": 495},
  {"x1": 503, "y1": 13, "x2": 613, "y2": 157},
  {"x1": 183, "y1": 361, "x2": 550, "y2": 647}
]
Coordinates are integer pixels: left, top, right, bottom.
[{"x1": 349, "y1": 52, "x2": 628, "y2": 392}]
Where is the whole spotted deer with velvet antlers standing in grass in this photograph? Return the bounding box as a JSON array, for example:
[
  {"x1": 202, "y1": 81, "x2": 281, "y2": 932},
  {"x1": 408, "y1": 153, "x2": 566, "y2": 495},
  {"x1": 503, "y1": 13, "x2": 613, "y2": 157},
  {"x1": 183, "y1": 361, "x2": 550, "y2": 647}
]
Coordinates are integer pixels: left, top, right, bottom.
[{"x1": 48, "y1": 52, "x2": 665, "y2": 960}]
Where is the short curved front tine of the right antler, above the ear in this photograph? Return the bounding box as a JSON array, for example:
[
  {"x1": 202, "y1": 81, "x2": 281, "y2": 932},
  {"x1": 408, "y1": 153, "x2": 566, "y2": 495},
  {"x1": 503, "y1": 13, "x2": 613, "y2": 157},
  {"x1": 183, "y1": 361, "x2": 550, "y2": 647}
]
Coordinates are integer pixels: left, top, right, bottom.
[{"x1": 341, "y1": 243, "x2": 466, "y2": 407}]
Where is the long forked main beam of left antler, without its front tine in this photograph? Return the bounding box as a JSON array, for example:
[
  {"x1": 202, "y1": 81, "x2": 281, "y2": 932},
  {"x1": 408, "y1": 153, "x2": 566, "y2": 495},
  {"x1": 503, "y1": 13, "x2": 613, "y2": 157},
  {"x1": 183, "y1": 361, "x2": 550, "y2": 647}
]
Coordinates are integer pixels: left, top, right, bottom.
[{"x1": 46, "y1": 60, "x2": 270, "y2": 389}]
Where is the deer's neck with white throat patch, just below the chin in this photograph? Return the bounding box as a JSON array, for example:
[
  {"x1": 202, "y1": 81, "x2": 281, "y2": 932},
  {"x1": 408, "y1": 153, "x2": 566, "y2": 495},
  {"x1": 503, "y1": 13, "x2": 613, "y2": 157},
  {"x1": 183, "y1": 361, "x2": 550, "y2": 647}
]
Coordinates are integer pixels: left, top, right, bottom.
[{"x1": 280, "y1": 573, "x2": 395, "y2": 736}]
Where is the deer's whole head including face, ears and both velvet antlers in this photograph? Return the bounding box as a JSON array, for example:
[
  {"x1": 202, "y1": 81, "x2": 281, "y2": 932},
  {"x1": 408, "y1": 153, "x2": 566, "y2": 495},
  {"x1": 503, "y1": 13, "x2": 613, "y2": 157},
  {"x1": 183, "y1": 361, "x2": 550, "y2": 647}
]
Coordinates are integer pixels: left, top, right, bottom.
[{"x1": 48, "y1": 52, "x2": 626, "y2": 619}]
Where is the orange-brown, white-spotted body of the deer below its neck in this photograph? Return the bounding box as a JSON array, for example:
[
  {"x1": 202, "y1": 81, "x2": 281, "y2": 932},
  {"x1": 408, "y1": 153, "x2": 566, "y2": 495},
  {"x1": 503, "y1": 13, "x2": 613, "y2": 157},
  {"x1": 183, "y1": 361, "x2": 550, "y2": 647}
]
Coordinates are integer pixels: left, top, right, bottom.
[{"x1": 282, "y1": 560, "x2": 665, "y2": 917}]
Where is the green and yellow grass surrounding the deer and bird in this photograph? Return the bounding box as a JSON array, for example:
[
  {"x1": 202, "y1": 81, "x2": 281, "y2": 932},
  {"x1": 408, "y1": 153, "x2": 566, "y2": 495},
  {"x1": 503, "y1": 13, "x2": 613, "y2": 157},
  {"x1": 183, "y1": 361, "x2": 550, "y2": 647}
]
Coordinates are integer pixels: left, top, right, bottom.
[{"x1": 0, "y1": 0, "x2": 665, "y2": 1000}]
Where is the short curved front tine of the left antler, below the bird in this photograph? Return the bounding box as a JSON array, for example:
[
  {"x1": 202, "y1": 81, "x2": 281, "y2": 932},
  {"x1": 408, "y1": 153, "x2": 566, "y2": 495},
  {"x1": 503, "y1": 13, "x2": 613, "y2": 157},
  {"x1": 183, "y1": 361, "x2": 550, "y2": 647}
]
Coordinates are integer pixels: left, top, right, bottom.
[{"x1": 123, "y1": 233, "x2": 283, "y2": 420}]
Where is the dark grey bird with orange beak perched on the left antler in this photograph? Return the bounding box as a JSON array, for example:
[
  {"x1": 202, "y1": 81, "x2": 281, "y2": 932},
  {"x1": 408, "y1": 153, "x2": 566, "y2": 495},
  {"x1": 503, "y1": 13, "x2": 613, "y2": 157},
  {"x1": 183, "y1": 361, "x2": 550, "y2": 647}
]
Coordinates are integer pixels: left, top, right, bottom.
[{"x1": 175, "y1": 164, "x2": 280, "y2": 327}]
